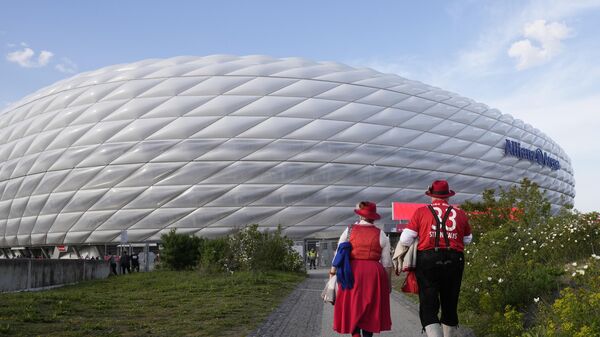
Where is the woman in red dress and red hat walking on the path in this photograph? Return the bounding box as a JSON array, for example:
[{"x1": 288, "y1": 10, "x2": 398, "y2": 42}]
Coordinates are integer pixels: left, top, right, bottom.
[{"x1": 329, "y1": 201, "x2": 392, "y2": 337}]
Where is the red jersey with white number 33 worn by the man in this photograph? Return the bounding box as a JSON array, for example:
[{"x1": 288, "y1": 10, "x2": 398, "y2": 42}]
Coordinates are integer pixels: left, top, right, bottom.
[{"x1": 406, "y1": 200, "x2": 471, "y2": 252}]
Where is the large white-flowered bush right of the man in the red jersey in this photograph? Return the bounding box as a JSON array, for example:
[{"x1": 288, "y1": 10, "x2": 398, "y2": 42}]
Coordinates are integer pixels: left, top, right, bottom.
[{"x1": 459, "y1": 180, "x2": 600, "y2": 337}]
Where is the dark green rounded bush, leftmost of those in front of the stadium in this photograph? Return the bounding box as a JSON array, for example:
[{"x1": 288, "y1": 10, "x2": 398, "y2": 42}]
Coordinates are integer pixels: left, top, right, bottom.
[{"x1": 160, "y1": 228, "x2": 204, "y2": 270}]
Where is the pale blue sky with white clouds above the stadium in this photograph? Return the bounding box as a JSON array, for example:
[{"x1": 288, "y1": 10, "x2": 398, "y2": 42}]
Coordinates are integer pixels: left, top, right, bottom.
[{"x1": 0, "y1": 0, "x2": 600, "y2": 211}]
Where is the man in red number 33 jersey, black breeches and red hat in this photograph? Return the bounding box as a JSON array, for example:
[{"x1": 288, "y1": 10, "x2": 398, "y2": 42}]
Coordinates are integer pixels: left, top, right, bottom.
[{"x1": 400, "y1": 180, "x2": 473, "y2": 337}]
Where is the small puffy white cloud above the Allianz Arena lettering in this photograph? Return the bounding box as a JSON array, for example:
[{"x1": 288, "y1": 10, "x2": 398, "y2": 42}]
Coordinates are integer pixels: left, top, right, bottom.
[{"x1": 508, "y1": 20, "x2": 572, "y2": 70}]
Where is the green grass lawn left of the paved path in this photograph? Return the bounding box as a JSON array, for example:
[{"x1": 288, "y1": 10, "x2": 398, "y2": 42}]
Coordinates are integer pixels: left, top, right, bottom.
[{"x1": 0, "y1": 271, "x2": 304, "y2": 337}]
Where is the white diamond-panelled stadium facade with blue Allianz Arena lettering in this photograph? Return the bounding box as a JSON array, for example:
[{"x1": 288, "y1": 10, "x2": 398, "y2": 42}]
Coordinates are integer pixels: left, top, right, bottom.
[{"x1": 0, "y1": 55, "x2": 575, "y2": 255}]
